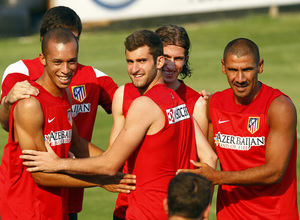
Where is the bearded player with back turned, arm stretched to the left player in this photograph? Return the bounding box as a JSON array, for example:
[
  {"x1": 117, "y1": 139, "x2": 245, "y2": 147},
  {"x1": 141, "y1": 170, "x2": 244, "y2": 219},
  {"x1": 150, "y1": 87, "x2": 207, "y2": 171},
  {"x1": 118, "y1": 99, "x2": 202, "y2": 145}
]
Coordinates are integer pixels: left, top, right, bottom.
[{"x1": 22, "y1": 30, "x2": 218, "y2": 219}]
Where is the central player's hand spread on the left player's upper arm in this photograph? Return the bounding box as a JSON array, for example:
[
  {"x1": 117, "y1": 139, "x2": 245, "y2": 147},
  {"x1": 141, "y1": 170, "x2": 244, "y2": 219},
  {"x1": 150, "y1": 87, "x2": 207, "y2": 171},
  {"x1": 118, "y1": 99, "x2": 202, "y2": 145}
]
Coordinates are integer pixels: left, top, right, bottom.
[{"x1": 20, "y1": 141, "x2": 60, "y2": 173}]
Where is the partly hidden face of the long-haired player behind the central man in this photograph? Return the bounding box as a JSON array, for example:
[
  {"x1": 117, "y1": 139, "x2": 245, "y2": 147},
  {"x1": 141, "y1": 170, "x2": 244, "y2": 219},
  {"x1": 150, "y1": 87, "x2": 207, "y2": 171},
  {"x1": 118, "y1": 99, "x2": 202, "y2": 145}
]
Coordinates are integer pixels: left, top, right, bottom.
[{"x1": 163, "y1": 45, "x2": 188, "y2": 89}]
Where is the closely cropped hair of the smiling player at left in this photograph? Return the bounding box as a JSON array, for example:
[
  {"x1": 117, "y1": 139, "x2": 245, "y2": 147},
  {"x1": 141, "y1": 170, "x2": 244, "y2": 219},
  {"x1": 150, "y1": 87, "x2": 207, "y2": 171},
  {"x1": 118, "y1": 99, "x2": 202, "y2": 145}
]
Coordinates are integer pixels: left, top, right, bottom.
[{"x1": 42, "y1": 27, "x2": 78, "y2": 56}]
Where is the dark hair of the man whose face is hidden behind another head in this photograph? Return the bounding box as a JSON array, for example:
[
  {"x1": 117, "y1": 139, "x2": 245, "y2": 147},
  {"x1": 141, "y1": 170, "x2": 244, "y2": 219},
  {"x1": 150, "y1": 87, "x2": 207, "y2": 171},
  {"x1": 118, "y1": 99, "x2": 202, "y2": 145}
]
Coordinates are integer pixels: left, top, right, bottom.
[{"x1": 40, "y1": 6, "x2": 82, "y2": 38}]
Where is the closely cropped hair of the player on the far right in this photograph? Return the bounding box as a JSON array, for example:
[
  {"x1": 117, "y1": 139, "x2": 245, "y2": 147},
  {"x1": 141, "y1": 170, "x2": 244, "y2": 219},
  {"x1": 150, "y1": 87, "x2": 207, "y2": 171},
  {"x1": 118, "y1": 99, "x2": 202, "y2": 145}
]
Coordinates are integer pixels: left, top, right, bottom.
[{"x1": 223, "y1": 38, "x2": 260, "y2": 65}]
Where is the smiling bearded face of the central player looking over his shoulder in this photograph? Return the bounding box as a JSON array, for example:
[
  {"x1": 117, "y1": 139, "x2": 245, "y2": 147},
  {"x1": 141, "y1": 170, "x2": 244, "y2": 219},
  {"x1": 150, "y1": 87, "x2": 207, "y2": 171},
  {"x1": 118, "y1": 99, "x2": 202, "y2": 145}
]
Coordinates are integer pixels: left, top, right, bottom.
[{"x1": 126, "y1": 46, "x2": 164, "y2": 94}]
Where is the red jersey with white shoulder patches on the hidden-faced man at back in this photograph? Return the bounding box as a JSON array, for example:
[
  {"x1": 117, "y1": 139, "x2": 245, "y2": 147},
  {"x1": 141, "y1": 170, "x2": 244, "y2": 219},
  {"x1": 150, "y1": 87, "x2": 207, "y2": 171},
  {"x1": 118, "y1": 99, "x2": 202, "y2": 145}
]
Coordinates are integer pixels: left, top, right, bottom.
[{"x1": 1, "y1": 58, "x2": 118, "y2": 213}]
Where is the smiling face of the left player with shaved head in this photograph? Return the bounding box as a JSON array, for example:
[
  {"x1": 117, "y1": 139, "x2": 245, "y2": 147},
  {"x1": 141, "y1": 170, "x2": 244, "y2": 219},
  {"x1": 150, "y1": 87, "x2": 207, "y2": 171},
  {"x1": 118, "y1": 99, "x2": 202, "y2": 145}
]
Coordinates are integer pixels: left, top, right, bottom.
[{"x1": 40, "y1": 38, "x2": 78, "y2": 96}]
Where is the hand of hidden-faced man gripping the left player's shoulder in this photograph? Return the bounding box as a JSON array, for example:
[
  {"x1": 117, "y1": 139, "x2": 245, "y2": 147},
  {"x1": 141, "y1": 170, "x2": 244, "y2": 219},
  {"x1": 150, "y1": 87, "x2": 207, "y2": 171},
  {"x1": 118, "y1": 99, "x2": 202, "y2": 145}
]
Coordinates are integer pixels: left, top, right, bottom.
[{"x1": 4, "y1": 80, "x2": 39, "y2": 105}]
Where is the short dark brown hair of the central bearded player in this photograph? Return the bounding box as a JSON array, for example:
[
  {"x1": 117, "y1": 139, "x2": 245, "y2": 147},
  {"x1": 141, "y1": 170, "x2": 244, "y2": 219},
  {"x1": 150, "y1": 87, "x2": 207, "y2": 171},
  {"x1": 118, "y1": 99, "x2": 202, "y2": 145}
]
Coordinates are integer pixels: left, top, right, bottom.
[{"x1": 124, "y1": 30, "x2": 163, "y2": 63}]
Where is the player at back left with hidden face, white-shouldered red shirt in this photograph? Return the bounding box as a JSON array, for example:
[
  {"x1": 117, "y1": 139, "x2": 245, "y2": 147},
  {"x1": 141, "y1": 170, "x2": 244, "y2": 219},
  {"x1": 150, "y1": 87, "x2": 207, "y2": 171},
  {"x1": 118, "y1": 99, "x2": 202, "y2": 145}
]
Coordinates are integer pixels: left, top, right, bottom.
[{"x1": 0, "y1": 6, "x2": 118, "y2": 219}]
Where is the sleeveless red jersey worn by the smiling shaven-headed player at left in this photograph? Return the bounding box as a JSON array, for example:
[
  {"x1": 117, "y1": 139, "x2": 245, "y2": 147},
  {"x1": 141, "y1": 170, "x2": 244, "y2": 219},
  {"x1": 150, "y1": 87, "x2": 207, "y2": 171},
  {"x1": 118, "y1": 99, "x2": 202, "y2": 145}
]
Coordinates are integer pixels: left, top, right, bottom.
[{"x1": 0, "y1": 82, "x2": 72, "y2": 220}]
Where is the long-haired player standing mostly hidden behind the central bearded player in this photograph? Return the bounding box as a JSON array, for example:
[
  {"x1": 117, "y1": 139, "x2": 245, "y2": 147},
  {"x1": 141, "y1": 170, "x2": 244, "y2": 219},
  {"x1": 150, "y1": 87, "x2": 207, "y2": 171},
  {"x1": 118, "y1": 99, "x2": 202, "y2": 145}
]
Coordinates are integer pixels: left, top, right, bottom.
[{"x1": 110, "y1": 24, "x2": 208, "y2": 220}]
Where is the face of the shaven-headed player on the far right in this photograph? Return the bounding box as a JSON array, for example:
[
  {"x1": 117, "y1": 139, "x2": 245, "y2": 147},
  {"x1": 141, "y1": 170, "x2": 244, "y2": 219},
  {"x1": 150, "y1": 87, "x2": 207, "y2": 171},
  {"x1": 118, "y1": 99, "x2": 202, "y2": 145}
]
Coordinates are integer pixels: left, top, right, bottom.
[{"x1": 221, "y1": 53, "x2": 264, "y2": 105}]
